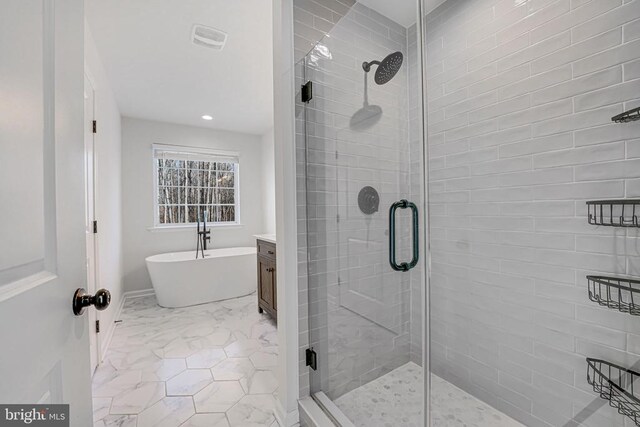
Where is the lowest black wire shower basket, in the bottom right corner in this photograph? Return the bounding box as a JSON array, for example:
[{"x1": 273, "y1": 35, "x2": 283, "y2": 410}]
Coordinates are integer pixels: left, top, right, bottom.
[{"x1": 587, "y1": 358, "x2": 640, "y2": 426}]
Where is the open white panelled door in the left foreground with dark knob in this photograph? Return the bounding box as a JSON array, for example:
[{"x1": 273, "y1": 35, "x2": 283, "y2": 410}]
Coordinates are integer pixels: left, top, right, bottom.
[{"x1": 0, "y1": 0, "x2": 93, "y2": 427}]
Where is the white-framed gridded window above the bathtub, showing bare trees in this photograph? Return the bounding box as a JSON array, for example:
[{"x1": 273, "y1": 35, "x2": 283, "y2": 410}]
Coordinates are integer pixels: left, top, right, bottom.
[{"x1": 153, "y1": 145, "x2": 239, "y2": 226}]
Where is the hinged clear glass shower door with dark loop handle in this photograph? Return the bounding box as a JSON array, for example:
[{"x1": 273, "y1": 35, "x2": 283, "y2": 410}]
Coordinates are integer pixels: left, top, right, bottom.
[{"x1": 298, "y1": 0, "x2": 425, "y2": 426}]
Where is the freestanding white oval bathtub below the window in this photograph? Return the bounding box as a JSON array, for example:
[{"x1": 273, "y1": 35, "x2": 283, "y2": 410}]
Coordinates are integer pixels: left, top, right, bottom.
[{"x1": 146, "y1": 247, "x2": 257, "y2": 308}]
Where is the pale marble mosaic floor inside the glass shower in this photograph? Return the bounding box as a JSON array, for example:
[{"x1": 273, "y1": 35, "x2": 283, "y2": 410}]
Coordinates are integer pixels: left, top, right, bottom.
[{"x1": 334, "y1": 362, "x2": 524, "y2": 427}]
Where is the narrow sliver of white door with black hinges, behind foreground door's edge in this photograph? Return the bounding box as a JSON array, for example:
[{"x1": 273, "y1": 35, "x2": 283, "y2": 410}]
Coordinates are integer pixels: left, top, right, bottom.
[{"x1": 84, "y1": 74, "x2": 100, "y2": 375}]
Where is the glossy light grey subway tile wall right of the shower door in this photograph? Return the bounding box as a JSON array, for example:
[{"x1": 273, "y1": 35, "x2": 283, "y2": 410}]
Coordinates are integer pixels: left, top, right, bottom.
[{"x1": 427, "y1": 0, "x2": 640, "y2": 427}]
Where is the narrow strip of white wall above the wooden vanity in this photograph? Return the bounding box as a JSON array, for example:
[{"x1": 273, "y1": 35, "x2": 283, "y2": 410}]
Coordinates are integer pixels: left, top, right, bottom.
[{"x1": 262, "y1": 129, "x2": 276, "y2": 234}]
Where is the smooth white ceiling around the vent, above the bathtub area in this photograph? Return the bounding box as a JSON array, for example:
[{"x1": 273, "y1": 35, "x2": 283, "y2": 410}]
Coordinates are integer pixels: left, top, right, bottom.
[{"x1": 85, "y1": 0, "x2": 273, "y2": 134}]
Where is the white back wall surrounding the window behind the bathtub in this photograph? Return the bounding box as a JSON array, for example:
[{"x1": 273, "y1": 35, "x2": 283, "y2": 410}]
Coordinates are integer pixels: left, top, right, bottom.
[{"x1": 122, "y1": 117, "x2": 264, "y2": 291}]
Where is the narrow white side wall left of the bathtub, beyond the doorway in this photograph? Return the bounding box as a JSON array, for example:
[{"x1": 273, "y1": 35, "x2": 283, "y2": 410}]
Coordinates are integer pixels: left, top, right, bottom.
[{"x1": 85, "y1": 23, "x2": 122, "y2": 352}]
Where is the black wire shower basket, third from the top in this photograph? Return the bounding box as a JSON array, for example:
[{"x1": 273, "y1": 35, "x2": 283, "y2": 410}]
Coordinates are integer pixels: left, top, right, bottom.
[{"x1": 587, "y1": 276, "x2": 640, "y2": 316}]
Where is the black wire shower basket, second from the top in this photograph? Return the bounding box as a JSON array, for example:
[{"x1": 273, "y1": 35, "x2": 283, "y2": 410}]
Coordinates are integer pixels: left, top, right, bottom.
[{"x1": 587, "y1": 199, "x2": 640, "y2": 228}]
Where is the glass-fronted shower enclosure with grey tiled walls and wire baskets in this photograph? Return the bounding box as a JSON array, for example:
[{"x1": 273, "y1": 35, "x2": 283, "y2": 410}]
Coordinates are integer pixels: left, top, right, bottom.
[{"x1": 296, "y1": 0, "x2": 640, "y2": 427}]
